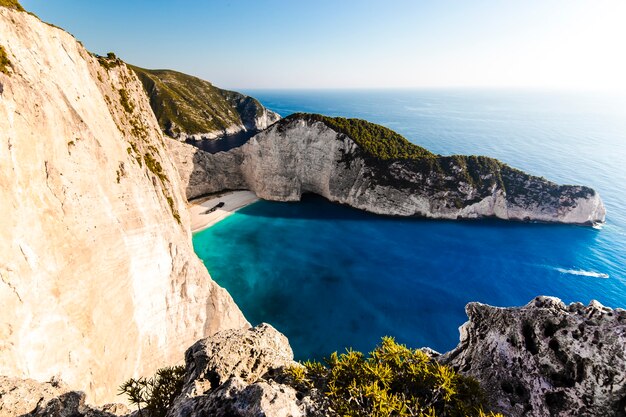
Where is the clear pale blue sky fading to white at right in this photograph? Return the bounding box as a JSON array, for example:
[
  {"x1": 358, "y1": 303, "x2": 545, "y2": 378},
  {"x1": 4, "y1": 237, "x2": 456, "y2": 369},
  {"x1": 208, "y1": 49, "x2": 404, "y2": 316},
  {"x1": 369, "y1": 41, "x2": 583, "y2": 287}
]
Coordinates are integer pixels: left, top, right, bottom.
[{"x1": 22, "y1": 0, "x2": 626, "y2": 91}]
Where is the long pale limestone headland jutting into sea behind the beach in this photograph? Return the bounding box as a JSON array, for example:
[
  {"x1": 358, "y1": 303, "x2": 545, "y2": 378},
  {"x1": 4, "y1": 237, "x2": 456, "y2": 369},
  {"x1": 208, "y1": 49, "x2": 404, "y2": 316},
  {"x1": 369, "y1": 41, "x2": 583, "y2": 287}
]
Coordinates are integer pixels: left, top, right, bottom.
[{"x1": 168, "y1": 114, "x2": 605, "y2": 225}]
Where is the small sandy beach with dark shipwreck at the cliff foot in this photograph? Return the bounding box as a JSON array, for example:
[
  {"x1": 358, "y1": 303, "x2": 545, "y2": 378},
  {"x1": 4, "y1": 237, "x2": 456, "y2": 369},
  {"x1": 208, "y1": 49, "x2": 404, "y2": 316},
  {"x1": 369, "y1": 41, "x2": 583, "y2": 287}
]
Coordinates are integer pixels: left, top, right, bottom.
[{"x1": 189, "y1": 191, "x2": 259, "y2": 233}]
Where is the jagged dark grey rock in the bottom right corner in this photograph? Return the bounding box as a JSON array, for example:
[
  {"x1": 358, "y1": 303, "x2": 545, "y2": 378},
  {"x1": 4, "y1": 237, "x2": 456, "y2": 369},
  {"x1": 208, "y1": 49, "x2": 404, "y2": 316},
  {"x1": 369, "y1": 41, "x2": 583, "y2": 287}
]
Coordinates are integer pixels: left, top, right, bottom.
[{"x1": 441, "y1": 297, "x2": 626, "y2": 417}]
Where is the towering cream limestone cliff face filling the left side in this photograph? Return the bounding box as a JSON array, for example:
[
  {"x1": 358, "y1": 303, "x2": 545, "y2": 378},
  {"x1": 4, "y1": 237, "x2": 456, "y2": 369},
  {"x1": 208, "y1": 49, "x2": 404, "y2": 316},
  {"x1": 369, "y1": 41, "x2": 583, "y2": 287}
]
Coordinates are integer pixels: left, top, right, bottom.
[{"x1": 0, "y1": 7, "x2": 247, "y2": 404}]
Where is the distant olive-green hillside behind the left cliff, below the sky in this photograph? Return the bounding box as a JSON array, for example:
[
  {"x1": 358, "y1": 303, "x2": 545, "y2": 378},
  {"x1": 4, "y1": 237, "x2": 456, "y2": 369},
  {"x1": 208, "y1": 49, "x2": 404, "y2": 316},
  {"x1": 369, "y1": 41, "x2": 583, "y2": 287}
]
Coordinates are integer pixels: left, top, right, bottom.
[{"x1": 131, "y1": 66, "x2": 280, "y2": 140}]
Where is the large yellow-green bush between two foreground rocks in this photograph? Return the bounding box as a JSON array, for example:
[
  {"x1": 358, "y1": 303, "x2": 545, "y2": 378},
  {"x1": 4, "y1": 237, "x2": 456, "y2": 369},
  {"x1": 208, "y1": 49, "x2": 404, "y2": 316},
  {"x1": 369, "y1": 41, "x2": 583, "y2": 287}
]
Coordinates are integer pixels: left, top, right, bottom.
[{"x1": 284, "y1": 337, "x2": 497, "y2": 417}]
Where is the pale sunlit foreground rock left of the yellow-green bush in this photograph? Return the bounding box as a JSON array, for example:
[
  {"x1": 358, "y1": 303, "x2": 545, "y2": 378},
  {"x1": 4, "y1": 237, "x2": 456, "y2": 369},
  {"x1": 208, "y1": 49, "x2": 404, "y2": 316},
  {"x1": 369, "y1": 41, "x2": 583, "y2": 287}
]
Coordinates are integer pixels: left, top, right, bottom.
[{"x1": 167, "y1": 324, "x2": 309, "y2": 417}]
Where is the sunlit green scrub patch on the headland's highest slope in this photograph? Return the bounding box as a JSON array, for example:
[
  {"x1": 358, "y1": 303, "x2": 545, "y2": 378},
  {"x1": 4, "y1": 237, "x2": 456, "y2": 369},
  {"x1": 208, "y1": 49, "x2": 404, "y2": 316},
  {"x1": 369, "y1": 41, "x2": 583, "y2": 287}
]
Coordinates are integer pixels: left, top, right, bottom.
[{"x1": 286, "y1": 113, "x2": 436, "y2": 159}]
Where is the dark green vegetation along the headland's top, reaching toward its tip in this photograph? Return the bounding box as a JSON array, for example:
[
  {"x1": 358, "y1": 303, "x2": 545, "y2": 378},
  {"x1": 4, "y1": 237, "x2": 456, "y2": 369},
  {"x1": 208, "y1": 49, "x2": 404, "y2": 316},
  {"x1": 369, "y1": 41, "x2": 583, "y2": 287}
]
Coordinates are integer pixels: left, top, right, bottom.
[{"x1": 278, "y1": 113, "x2": 572, "y2": 202}]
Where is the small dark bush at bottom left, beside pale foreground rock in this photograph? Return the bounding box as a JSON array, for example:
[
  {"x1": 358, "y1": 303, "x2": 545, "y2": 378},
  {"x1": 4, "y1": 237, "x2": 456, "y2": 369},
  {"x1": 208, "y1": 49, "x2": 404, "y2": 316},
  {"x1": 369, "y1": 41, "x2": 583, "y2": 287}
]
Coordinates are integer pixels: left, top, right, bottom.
[{"x1": 119, "y1": 366, "x2": 185, "y2": 417}]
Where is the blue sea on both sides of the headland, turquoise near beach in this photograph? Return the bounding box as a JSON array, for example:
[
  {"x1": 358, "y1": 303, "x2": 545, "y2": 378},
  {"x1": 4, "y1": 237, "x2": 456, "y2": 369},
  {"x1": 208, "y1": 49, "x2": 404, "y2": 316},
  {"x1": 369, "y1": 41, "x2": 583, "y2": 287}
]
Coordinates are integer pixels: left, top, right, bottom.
[{"x1": 194, "y1": 90, "x2": 626, "y2": 359}]
